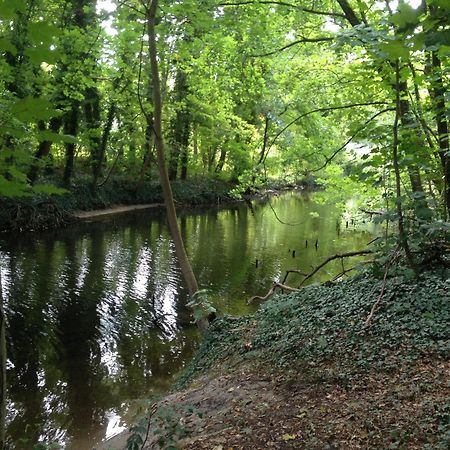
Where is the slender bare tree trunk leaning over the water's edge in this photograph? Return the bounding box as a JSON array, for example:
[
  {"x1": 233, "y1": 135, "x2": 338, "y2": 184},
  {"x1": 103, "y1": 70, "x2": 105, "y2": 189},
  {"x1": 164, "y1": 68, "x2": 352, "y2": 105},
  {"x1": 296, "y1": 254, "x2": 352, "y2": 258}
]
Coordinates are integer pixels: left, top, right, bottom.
[{"x1": 147, "y1": 0, "x2": 208, "y2": 329}]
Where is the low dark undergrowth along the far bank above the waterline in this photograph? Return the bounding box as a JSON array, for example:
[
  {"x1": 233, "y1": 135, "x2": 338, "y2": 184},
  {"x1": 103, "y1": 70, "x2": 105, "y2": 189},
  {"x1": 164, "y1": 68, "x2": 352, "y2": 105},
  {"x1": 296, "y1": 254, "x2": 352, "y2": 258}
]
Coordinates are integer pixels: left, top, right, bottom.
[{"x1": 0, "y1": 177, "x2": 234, "y2": 232}]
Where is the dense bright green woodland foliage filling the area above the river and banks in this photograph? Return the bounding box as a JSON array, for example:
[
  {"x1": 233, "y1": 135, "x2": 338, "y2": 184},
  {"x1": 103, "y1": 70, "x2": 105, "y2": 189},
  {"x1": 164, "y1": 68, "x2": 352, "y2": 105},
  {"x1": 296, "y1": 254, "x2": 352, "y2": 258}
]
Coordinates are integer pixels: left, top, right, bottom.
[{"x1": 0, "y1": 0, "x2": 450, "y2": 237}]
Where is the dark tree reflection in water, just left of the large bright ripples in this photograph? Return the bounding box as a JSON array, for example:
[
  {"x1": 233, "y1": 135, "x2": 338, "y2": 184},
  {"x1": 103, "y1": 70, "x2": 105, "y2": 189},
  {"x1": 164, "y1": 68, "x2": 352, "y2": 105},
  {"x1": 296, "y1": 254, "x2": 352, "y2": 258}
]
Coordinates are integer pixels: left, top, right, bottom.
[{"x1": 56, "y1": 233, "x2": 109, "y2": 438}]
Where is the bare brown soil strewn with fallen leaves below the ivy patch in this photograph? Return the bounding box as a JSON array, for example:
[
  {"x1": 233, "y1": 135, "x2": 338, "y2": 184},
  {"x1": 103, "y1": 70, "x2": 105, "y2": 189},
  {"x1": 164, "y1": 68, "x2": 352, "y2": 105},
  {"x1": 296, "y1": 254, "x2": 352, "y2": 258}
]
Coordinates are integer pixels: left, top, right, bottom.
[{"x1": 103, "y1": 361, "x2": 450, "y2": 450}]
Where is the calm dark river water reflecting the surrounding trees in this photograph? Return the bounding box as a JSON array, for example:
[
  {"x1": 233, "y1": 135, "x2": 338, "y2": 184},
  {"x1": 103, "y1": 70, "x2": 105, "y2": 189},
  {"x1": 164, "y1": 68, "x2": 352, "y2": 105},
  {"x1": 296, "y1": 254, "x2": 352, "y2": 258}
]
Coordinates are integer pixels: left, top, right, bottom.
[{"x1": 1, "y1": 193, "x2": 372, "y2": 450}]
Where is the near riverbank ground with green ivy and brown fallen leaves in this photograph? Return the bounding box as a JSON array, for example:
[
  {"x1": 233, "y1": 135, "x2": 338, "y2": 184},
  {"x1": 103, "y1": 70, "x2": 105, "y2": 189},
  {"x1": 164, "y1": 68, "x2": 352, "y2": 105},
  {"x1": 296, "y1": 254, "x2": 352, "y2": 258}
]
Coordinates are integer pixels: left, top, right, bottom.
[{"x1": 103, "y1": 269, "x2": 450, "y2": 450}]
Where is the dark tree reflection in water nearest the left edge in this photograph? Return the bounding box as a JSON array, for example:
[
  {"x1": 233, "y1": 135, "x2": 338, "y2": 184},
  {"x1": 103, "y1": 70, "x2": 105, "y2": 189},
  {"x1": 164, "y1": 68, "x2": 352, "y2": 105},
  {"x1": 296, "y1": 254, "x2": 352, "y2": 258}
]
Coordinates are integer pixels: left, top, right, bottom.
[{"x1": 7, "y1": 241, "x2": 54, "y2": 448}]
